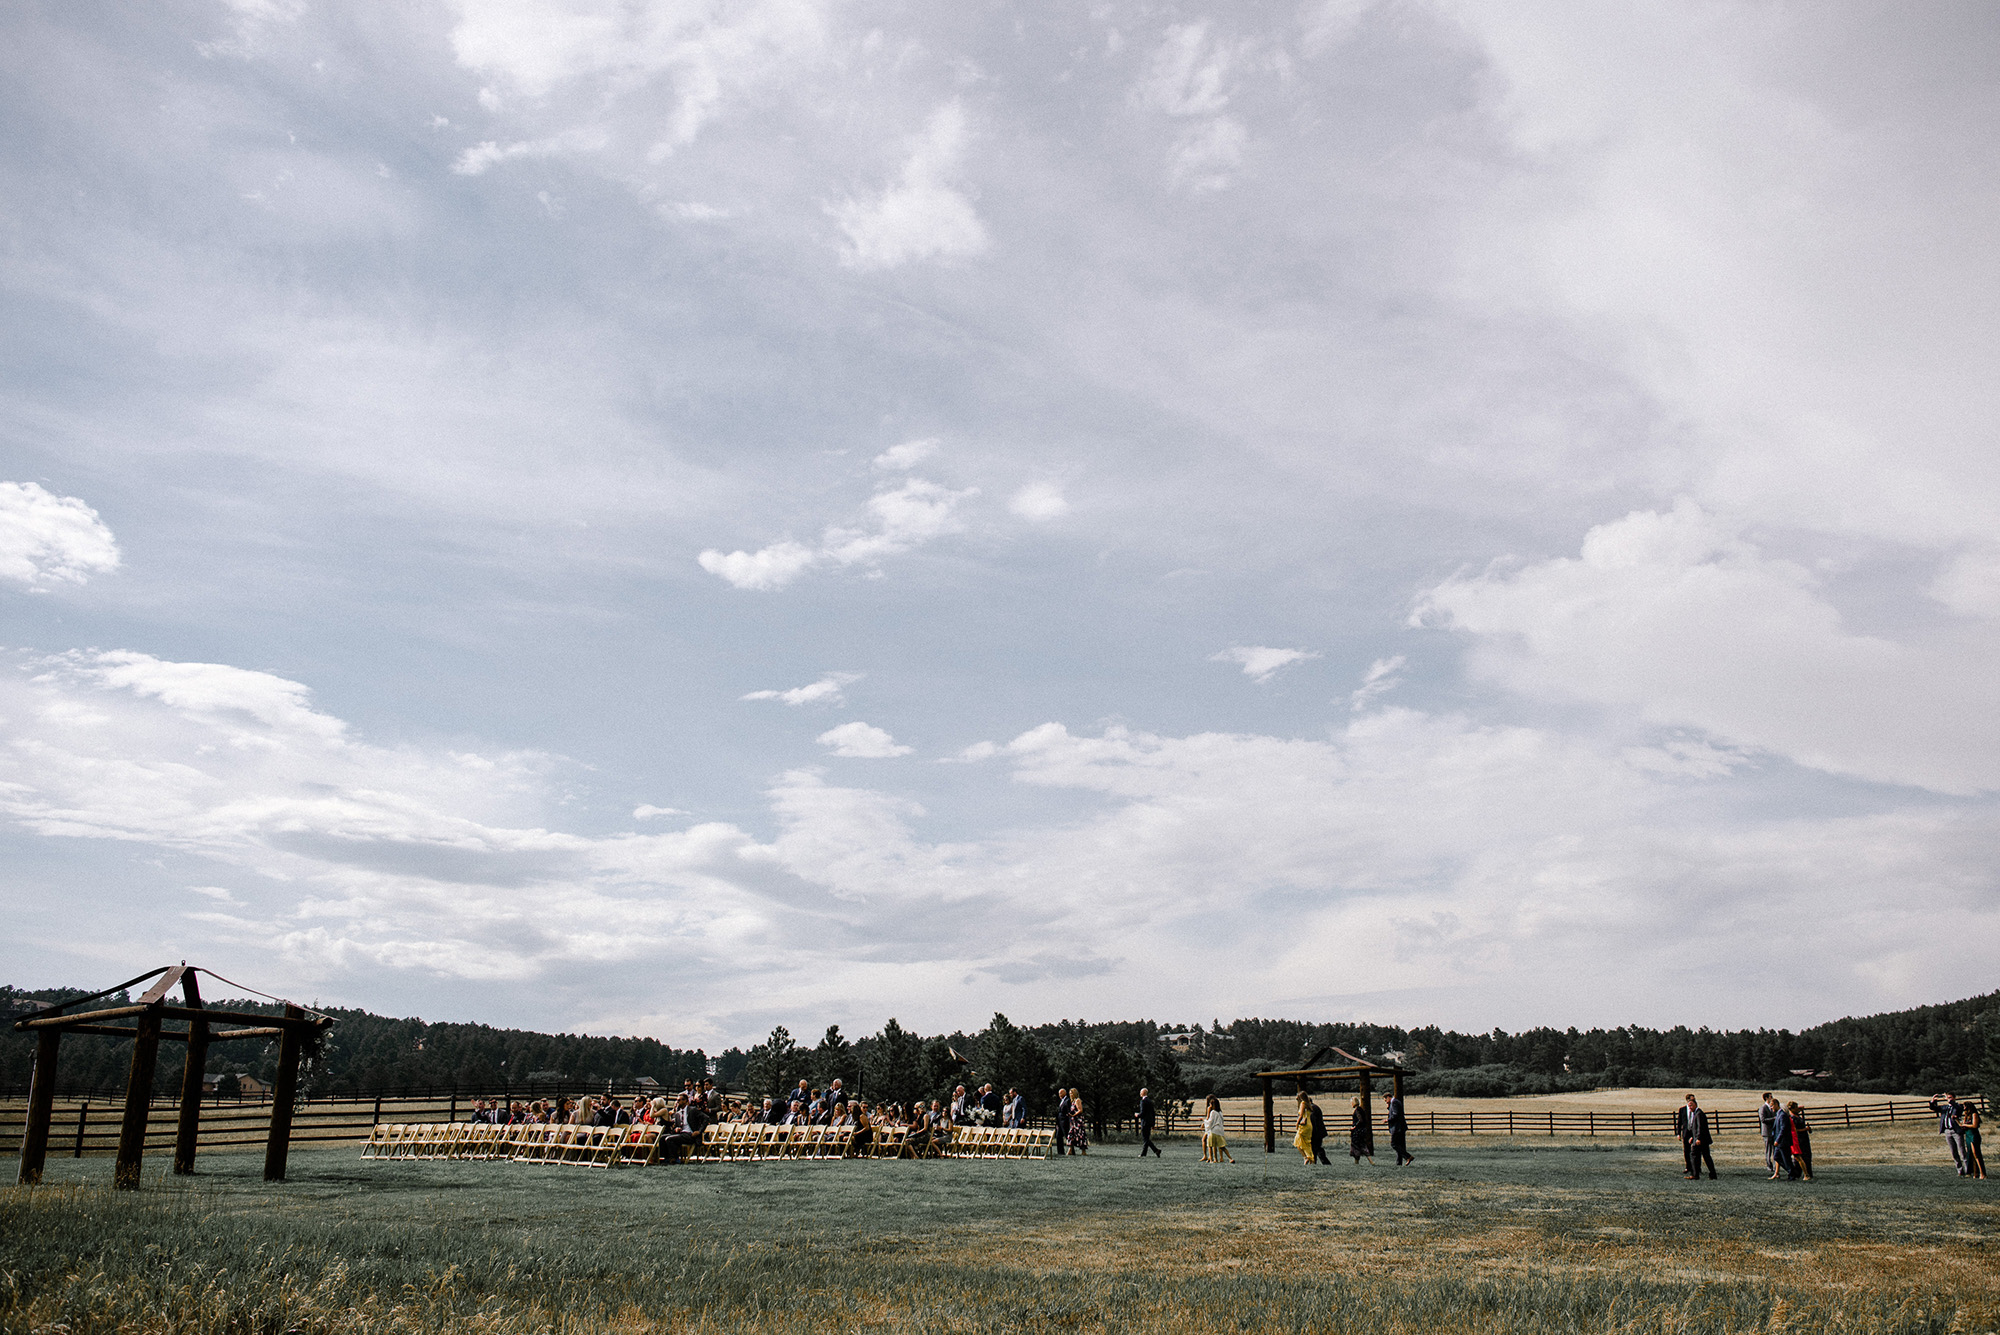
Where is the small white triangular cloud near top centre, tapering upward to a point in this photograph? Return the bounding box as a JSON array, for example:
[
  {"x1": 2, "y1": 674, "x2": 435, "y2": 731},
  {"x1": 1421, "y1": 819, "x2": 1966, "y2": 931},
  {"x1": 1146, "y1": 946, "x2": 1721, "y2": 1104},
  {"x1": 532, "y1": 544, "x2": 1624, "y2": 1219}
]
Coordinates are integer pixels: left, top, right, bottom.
[{"x1": 828, "y1": 102, "x2": 986, "y2": 270}]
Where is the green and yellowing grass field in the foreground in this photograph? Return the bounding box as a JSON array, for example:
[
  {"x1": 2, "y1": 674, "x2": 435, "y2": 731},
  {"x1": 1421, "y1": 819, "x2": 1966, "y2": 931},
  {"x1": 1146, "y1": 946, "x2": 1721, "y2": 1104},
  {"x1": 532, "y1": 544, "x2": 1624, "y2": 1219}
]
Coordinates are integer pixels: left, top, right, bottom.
[{"x1": 0, "y1": 1145, "x2": 2000, "y2": 1335}]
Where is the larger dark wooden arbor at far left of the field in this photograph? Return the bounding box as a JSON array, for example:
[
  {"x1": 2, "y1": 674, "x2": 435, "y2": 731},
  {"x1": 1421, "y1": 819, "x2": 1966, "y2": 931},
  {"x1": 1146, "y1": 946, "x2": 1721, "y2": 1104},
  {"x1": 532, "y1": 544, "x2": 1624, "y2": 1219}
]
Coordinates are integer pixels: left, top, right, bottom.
[{"x1": 14, "y1": 963, "x2": 334, "y2": 1187}]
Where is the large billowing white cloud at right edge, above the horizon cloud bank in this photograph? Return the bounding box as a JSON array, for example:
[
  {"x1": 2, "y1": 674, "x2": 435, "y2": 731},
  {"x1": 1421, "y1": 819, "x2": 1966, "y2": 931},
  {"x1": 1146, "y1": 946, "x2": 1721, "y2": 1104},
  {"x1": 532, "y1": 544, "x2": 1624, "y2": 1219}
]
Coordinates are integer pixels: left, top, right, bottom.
[{"x1": 1416, "y1": 502, "x2": 2000, "y2": 793}]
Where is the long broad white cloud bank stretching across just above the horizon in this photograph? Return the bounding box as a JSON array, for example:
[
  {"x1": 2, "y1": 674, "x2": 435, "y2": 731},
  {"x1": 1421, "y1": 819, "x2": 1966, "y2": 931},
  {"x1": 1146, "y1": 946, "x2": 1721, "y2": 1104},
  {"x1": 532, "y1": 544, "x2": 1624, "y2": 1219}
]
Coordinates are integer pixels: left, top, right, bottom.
[{"x1": 0, "y1": 654, "x2": 2000, "y2": 1041}]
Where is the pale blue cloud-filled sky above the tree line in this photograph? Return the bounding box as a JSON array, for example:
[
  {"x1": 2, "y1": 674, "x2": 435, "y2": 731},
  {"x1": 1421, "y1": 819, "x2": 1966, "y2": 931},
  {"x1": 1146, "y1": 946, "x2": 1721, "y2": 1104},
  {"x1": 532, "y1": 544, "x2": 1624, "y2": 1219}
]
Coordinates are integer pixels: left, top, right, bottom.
[{"x1": 0, "y1": 0, "x2": 2000, "y2": 1051}]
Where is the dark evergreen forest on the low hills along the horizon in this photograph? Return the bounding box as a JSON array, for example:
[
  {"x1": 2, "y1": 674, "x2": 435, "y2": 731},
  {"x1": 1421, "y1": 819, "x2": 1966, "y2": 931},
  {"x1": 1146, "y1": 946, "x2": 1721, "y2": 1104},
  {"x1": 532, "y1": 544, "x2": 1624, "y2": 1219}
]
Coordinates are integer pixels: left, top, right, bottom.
[{"x1": 0, "y1": 987, "x2": 2000, "y2": 1113}]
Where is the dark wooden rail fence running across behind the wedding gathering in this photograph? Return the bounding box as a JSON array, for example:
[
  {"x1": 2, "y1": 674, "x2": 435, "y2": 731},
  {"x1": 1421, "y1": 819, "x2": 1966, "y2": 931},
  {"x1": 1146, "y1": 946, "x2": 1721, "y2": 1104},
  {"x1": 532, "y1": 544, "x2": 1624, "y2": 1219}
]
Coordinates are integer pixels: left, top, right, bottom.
[{"x1": 0, "y1": 1089, "x2": 1992, "y2": 1157}]
